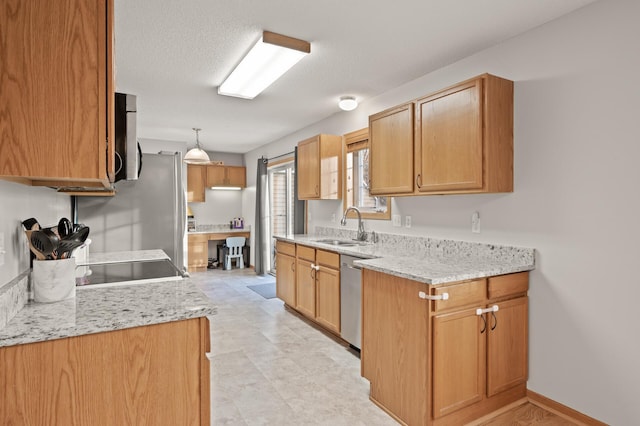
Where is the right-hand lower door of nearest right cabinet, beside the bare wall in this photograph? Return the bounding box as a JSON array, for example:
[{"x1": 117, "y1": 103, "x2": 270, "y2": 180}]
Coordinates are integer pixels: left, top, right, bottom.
[{"x1": 487, "y1": 297, "x2": 528, "y2": 396}]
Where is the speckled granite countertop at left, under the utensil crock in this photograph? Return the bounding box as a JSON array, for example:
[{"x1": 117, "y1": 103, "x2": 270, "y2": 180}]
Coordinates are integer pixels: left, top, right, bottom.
[{"x1": 0, "y1": 279, "x2": 216, "y2": 347}]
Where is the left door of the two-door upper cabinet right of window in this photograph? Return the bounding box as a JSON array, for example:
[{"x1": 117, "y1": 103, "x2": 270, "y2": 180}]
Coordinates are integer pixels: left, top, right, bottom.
[{"x1": 369, "y1": 103, "x2": 414, "y2": 195}]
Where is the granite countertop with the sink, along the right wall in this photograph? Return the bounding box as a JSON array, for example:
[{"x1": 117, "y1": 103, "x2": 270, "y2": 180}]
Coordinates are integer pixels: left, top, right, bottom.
[{"x1": 275, "y1": 235, "x2": 535, "y2": 285}]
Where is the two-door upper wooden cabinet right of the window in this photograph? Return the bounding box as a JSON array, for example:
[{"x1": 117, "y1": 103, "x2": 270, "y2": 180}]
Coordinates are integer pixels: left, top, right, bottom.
[{"x1": 369, "y1": 74, "x2": 513, "y2": 195}]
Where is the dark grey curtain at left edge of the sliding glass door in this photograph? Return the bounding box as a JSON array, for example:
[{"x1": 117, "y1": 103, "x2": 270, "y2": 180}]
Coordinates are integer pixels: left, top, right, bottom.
[{"x1": 254, "y1": 157, "x2": 270, "y2": 275}]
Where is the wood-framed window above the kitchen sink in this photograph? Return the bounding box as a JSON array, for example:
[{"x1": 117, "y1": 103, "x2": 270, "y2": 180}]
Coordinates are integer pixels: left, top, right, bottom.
[{"x1": 342, "y1": 129, "x2": 391, "y2": 220}]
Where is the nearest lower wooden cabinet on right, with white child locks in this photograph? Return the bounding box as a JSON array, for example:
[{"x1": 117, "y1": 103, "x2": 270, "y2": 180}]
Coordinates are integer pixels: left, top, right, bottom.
[{"x1": 361, "y1": 269, "x2": 528, "y2": 425}]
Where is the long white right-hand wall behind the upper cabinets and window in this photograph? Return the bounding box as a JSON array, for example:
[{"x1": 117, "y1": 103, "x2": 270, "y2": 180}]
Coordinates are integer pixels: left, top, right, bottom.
[{"x1": 244, "y1": 0, "x2": 640, "y2": 425}]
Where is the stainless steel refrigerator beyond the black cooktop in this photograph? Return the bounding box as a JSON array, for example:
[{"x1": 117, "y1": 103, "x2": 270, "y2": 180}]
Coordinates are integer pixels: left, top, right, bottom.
[{"x1": 76, "y1": 152, "x2": 187, "y2": 271}]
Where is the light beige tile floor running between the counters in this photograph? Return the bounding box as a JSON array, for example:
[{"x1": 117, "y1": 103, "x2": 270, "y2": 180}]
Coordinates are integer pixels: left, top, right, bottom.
[{"x1": 192, "y1": 269, "x2": 397, "y2": 426}]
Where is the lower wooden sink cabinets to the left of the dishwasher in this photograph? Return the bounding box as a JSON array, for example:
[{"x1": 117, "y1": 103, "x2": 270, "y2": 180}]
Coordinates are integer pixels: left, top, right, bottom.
[{"x1": 276, "y1": 241, "x2": 340, "y2": 334}]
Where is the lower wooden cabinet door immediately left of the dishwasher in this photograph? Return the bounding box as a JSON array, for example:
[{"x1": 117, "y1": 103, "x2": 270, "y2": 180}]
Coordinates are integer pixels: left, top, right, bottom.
[{"x1": 316, "y1": 266, "x2": 340, "y2": 333}]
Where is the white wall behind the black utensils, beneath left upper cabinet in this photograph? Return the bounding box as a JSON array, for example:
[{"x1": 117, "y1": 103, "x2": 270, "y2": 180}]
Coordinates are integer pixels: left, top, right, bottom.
[{"x1": 0, "y1": 180, "x2": 71, "y2": 287}]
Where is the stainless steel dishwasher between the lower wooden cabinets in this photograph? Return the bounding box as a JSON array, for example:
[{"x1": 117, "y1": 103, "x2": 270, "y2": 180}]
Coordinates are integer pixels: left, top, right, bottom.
[{"x1": 340, "y1": 254, "x2": 362, "y2": 350}]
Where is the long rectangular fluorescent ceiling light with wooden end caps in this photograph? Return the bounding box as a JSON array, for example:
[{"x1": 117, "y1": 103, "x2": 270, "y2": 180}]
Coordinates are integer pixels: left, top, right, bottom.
[{"x1": 218, "y1": 31, "x2": 311, "y2": 99}]
